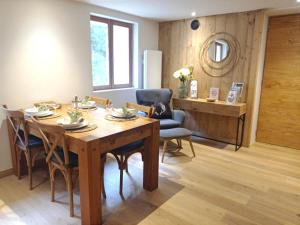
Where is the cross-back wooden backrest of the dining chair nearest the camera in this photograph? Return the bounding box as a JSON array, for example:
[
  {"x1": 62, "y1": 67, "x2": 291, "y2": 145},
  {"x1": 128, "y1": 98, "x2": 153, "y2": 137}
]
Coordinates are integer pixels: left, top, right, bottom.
[{"x1": 31, "y1": 117, "x2": 70, "y2": 166}]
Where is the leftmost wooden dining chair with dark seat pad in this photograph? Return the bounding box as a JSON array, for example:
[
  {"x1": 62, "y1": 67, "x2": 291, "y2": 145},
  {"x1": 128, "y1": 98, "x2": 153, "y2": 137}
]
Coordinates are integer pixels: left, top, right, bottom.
[{"x1": 2, "y1": 105, "x2": 44, "y2": 190}]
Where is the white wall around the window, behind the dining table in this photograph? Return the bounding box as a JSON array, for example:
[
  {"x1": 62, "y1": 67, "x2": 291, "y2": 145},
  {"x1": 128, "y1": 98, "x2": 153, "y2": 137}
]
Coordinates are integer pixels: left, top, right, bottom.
[{"x1": 0, "y1": 0, "x2": 158, "y2": 171}]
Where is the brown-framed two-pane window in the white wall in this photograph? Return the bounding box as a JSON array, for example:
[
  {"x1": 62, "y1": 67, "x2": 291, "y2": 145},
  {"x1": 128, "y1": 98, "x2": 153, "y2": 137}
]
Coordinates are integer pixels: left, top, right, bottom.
[{"x1": 90, "y1": 16, "x2": 132, "y2": 90}]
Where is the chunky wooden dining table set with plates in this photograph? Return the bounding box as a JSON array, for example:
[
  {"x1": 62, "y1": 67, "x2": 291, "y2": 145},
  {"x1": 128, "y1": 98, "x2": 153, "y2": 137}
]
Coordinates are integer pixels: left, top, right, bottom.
[{"x1": 8, "y1": 105, "x2": 159, "y2": 225}]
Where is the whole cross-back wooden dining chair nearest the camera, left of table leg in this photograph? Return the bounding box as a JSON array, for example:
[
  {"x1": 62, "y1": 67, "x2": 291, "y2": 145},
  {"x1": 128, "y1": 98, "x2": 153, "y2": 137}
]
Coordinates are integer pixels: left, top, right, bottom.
[{"x1": 32, "y1": 118, "x2": 78, "y2": 217}]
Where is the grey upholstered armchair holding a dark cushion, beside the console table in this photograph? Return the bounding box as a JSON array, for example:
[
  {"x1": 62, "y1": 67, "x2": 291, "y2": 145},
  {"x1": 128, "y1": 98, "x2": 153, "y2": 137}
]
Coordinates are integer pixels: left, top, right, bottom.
[{"x1": 136, "y1": 88, "x2": 185, "y2": 129}]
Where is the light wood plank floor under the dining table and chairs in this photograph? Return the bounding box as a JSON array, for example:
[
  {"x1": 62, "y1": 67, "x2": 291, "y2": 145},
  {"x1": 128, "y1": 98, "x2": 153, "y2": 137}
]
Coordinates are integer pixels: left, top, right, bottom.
[{"x1": 0, "y1": 142, "x2": 300, "y2": 225}]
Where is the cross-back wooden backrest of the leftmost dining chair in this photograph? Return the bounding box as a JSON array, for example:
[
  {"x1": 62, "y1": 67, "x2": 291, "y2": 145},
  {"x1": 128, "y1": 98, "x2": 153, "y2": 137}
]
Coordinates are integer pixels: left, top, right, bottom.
[{"x1": 0, "y1": 105, "x2": 28, "y2": 149}]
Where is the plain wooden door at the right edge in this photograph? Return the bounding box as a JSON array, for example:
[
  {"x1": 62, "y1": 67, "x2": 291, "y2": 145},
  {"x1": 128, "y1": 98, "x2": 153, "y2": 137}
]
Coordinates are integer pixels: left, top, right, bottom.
[{"x1": 257, "y1": 14, "x2": 300, "y2": 149}]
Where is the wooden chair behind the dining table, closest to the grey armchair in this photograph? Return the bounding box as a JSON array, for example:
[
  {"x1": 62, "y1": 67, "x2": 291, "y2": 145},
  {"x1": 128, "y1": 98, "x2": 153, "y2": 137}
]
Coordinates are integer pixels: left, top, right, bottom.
[{"x1": 111, "y1": 103, "x2": 153, "y2": 196}]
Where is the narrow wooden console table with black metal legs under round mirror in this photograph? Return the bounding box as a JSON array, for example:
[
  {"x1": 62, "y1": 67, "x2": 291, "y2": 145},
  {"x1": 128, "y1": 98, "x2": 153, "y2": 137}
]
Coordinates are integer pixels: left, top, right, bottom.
[{"x1": 173, "y1": 98, "x2": 246, "y2": 151}]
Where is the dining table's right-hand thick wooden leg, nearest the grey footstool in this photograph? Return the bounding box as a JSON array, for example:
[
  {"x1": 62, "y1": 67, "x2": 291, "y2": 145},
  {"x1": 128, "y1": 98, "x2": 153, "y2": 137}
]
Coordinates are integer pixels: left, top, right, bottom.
[{"x1": 143, "y1": 121, "x2": 159, "y2": 191}]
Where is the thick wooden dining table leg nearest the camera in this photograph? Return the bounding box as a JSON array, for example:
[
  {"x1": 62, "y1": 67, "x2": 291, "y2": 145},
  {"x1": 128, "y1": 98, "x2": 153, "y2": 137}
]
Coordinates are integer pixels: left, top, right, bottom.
[{"x1": 78, "y1": 141, "x2": 102, "y2": 225}]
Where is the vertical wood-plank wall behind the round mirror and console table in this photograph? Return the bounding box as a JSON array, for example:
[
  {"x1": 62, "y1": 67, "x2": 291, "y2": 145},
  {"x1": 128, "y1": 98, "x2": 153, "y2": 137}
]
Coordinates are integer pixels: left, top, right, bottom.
[{"x1": 159, "y1": 11, "x2": 264, "y2": 146}]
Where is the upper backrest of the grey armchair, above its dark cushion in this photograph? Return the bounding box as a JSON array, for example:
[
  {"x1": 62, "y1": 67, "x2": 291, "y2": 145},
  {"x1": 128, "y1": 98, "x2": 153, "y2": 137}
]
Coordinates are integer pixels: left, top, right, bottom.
[{"x1": 136, "y1": 88, "x2": 173, "y2": 106}]
